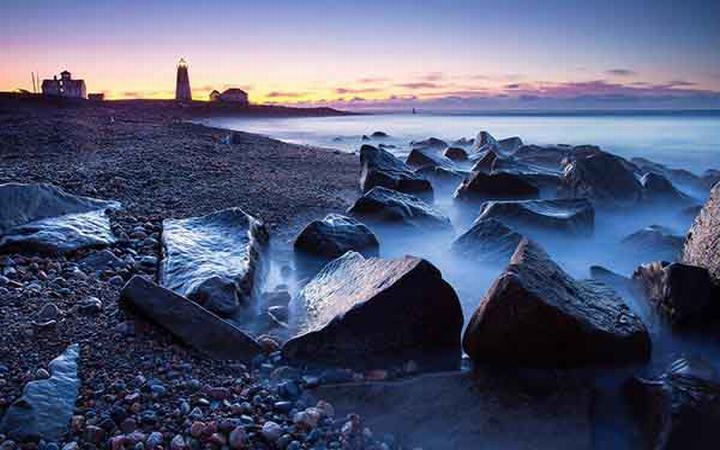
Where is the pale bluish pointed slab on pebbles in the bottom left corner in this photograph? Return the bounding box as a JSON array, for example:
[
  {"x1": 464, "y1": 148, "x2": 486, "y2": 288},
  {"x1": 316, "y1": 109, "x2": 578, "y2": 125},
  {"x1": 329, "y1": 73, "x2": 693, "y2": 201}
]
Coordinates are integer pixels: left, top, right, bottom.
[{"x1": 0, "y1": 344, "x2": 80, "y2": 442}]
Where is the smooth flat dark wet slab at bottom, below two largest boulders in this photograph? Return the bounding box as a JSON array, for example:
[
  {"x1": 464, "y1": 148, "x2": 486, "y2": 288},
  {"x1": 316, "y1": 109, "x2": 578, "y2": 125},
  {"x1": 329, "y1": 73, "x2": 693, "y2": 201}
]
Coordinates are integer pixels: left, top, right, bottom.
[{"x1": 312, "y1": 372, "x2": 593, "y2": 450}]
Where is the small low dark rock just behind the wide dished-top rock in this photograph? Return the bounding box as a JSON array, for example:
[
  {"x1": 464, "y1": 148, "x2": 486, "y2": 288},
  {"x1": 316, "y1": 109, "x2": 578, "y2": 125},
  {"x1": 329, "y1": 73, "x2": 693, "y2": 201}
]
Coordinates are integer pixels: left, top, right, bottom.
[{"x1": 454, "y1": 171, "x2": 540, "y2": 201}]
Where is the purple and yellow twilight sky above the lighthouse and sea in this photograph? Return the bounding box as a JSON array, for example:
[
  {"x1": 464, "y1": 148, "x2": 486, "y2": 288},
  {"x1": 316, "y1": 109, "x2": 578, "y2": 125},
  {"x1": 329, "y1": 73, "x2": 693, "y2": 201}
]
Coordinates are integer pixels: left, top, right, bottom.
[{"x1": 0, "y1": 0, "x2": 720, "y2": 110}]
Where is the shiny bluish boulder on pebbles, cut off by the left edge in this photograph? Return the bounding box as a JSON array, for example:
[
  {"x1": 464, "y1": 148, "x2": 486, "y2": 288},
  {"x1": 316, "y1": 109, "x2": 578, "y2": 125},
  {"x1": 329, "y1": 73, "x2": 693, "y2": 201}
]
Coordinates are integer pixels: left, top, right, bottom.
[{"x1": 0, "y1": 183, "x2": 120, "y2": 253}]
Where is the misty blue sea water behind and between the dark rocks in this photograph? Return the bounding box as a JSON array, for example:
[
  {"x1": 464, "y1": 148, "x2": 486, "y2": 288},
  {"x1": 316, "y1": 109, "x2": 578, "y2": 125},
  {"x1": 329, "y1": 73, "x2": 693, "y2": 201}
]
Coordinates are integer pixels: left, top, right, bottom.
[{"x1": 204, "y1": 114, "x2": 720, "y2": 448}]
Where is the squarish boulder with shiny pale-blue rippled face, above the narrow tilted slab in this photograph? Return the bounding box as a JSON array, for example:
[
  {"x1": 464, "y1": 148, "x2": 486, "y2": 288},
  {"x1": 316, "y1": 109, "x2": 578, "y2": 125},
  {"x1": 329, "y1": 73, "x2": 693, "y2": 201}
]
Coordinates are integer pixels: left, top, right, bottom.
[{"x1": 159, "y1": 208, "x2": 268, "y2": 317}]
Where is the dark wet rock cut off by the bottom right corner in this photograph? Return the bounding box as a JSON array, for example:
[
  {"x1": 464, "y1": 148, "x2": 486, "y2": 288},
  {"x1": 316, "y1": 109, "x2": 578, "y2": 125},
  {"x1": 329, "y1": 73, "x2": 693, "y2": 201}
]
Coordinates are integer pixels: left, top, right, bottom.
[{"x1": 625, "y1": 359, "x2": 720, "y2": 450}]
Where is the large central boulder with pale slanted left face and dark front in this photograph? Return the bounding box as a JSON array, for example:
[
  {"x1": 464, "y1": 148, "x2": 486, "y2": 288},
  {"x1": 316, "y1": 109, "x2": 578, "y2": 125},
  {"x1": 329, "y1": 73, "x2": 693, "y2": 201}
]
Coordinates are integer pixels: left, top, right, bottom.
[{"x1": 283, "y1": 252, "x2": 463, "y2": 368}]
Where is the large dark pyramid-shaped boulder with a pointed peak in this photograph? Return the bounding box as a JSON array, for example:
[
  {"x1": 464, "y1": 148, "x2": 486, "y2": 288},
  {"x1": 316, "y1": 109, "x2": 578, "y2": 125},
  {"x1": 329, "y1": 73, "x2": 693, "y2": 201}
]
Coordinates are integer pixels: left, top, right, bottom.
[{"x1": 463, "y1": 239, "x2": 650, "y2": 367}]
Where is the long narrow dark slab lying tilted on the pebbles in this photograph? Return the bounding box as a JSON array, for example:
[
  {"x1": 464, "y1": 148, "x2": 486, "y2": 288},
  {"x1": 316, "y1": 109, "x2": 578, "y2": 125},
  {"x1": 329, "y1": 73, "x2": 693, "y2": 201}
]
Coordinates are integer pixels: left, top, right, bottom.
[{"x1": 120, "y1": 276, "x2": 261, "y2": 360}]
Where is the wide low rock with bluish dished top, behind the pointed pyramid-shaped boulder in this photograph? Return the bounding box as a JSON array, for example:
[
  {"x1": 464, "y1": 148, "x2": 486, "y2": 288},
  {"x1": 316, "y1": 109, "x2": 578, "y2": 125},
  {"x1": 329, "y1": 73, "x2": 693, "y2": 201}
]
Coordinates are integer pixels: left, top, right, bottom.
[{"x1": 477, "y1": 199, "x2": 595, "y2": 235}]
